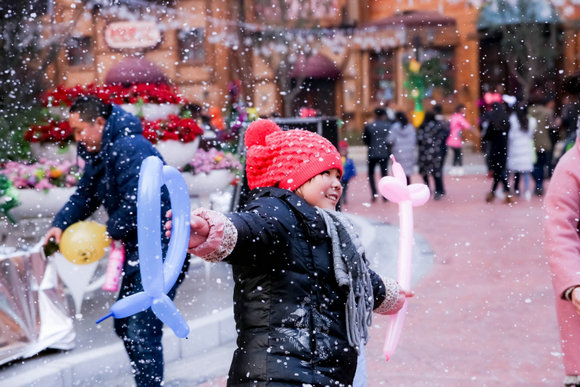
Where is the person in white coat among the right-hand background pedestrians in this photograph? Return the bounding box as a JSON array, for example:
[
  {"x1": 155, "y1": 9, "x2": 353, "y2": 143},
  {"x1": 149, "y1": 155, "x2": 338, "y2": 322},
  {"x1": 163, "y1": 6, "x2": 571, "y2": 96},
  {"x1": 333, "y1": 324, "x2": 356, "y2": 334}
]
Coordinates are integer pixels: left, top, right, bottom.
[{"x1": 507, "y1": 101, "x2": 537, "y2": 200}]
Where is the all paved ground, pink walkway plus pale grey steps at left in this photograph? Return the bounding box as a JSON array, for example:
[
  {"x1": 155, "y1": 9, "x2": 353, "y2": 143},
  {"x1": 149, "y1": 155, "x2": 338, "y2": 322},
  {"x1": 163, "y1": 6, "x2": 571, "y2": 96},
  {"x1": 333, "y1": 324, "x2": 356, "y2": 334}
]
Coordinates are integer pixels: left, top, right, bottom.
[{"x1": 0, "y1": 148, "x2": 564, "y2": 387}]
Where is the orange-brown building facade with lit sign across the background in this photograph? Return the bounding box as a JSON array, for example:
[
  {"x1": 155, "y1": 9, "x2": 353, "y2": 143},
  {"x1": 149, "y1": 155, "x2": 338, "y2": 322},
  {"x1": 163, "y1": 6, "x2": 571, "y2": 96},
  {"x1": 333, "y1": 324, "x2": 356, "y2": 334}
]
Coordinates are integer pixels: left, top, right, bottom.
[{"x1": 47, "y1": 0, "x2": 580, "y2": 136}]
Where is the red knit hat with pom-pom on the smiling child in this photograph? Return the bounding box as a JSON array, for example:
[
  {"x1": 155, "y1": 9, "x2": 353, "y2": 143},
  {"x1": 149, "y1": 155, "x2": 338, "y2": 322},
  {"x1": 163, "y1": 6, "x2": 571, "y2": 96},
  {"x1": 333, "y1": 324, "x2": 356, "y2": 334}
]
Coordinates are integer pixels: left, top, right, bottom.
[{"x1": 244, "y1": 120, "x2": 342, "y2": 191}]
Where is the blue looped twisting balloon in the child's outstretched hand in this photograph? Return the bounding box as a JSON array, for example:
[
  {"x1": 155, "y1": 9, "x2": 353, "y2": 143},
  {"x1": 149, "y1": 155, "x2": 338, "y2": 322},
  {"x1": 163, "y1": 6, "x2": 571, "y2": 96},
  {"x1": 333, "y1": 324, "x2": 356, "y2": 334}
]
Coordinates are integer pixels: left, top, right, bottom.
[{"x1": 97, "y1": 156, "x2": 190, "y2": 338}]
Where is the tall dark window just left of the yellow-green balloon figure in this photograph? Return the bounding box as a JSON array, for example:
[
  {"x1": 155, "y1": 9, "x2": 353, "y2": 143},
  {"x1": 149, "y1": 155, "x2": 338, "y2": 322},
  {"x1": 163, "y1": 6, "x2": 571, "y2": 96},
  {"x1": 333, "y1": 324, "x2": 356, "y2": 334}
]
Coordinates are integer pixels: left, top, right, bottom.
[{"x1": 370, "y1": 51, "x2": 395, "y2": 103}]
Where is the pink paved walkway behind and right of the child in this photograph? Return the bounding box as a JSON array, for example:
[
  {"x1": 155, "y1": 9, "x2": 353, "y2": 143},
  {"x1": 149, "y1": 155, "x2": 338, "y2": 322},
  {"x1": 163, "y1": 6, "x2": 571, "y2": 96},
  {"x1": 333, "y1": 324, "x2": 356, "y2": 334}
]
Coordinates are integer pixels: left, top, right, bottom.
[{"x1": 198, "y1": 174, "x2": 564, "y2": 386}]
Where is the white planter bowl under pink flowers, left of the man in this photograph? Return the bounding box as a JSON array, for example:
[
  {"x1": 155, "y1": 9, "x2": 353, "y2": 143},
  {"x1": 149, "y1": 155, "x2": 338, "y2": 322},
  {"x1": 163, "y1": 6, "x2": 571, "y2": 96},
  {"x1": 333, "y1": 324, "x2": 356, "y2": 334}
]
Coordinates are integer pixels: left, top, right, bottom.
[{"x1": 10, "y1": 187, "x2": 76, "y2": 220}]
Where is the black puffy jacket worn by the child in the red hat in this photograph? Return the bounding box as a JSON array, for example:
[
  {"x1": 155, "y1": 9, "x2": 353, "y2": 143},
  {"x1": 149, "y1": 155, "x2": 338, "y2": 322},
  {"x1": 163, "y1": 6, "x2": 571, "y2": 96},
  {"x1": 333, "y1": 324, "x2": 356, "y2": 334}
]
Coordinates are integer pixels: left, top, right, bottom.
[{"x1": 226, "y1": 188, "x2": 385, "y2": 386}]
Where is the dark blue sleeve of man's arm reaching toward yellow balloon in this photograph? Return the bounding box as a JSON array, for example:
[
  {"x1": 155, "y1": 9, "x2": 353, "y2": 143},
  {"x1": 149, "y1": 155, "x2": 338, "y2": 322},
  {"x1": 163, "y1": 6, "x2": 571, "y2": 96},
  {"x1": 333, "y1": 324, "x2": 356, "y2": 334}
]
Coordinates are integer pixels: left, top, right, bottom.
[{"x1": 52, "y1": 163, "x2": 103, "y2": 230}]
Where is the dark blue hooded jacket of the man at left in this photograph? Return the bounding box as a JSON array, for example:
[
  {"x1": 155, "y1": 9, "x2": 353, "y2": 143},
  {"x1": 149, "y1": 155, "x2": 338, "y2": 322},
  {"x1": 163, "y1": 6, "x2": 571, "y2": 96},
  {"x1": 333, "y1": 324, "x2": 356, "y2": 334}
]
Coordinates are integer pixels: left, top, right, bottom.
[{"x1": 52, "y1": 105, "x2": 169, "y2": 275}]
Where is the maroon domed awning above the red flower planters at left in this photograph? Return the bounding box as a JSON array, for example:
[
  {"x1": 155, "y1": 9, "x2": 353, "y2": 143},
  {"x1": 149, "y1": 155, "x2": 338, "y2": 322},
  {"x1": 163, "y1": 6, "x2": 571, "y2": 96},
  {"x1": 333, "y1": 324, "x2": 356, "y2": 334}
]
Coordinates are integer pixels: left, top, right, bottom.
[{"x1": 105, "y1": 57, "x2": 168, "y2": 85}]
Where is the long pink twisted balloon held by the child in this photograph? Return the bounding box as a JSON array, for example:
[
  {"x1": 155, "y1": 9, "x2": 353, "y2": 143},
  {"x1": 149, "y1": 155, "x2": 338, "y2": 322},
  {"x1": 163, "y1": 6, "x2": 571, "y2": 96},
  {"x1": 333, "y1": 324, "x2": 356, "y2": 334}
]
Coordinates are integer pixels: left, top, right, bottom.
[{"x1": 379, "y1": 155, "x2": 430, "y2": 361}]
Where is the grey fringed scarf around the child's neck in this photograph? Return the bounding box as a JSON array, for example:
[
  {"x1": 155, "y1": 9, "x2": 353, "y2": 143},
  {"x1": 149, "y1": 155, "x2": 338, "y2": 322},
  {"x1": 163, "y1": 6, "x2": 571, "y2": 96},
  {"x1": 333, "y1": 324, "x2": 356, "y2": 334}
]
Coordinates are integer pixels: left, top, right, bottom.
[{"x1": 318, "y1": 208, "x2": 374, "y2": 352}]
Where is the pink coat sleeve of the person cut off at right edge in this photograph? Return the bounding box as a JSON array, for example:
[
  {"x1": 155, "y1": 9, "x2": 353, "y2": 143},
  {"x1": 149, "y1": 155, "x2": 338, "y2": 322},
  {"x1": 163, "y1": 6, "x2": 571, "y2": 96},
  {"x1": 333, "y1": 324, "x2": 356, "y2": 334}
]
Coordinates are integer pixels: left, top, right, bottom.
[{"x1": 545, "y1": 151, "x2": 580, "y2": 296}]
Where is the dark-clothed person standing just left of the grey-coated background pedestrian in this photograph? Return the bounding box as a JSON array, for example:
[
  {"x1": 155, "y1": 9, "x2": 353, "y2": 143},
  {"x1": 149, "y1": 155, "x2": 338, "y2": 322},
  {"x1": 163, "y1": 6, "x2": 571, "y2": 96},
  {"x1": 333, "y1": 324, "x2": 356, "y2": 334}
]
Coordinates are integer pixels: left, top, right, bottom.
[{"x1": 362, "y1": 108, "x2": 393, "y2": 202}]
